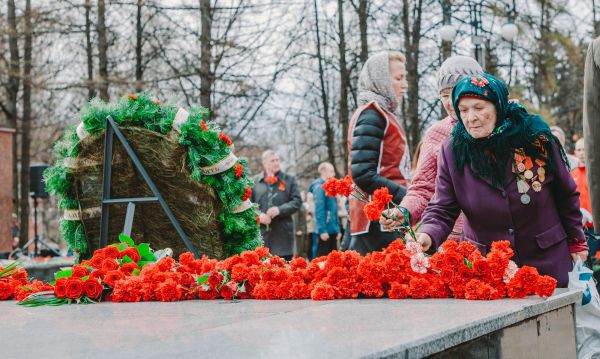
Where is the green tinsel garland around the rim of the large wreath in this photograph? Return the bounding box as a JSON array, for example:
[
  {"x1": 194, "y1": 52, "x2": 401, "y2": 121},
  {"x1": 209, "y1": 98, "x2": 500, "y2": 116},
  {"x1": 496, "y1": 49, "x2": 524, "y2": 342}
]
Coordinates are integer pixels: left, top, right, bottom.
[{"x1": 44, "y1": 93, "x2": 263, "y2": 256}]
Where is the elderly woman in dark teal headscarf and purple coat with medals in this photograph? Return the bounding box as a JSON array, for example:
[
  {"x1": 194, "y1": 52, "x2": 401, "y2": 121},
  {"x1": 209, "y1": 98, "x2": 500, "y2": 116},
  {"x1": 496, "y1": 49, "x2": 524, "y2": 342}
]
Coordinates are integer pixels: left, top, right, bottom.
[{"x1": 382, "y1": 74, "x2": 587, "y2": 287}]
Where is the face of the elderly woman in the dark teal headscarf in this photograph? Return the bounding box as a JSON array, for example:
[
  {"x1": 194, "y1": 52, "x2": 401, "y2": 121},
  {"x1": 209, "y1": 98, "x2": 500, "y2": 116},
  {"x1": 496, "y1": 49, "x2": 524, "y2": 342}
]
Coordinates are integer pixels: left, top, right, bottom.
[{"x1": 458, "y1": 97, "x2": 496, "y2": 138}]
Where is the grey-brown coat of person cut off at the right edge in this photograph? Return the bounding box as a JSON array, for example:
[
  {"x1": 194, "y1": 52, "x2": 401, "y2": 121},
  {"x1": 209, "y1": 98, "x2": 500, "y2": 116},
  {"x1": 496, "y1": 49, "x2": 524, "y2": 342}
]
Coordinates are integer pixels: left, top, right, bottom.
[{"x1": 583, "y1": 37, "x2": 600, "y2": 233}]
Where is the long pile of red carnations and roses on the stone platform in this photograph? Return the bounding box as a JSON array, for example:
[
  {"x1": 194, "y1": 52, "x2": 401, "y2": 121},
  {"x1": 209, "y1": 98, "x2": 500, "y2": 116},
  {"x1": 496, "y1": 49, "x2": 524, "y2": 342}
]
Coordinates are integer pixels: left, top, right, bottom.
[{"x1": 0, "y1": 236, "x2": 556, "y2": 304}]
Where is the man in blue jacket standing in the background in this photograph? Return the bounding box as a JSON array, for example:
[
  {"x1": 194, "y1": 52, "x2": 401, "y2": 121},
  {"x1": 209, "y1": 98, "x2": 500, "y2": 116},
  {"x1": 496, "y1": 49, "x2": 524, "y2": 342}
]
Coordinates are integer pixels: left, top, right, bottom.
[{"x1": 309, "y1": 162, "x2": 341, "y2": 257}]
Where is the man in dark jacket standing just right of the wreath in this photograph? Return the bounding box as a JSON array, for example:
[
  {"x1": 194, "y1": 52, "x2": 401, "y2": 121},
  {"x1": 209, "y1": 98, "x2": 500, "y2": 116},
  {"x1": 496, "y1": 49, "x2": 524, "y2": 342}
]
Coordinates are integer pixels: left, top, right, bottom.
[{"x1": 250, "y1": 150, "x2": 302, "y2": 260}]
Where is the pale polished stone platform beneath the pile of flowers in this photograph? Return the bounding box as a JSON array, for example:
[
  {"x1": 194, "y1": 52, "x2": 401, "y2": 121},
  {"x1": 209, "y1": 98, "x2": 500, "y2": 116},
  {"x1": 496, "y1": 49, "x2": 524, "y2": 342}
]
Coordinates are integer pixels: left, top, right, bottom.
[{"x1": 0, "y1": 289, "x2": 581, "y2": 359}]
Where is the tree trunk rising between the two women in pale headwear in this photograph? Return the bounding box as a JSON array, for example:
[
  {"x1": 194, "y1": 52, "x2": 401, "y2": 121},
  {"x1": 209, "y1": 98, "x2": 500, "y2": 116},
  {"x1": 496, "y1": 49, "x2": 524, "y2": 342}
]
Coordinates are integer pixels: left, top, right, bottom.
[{"x1": 402, "y1": 0, "x2": 423, "y2": 152}]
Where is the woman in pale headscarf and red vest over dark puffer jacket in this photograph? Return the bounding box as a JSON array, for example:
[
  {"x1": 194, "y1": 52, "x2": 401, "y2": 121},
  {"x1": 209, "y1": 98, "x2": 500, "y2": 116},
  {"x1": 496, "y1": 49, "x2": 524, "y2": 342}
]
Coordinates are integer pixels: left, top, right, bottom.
[{"x1": 348, "y1": 52, "x2": 410, "y2": 255}]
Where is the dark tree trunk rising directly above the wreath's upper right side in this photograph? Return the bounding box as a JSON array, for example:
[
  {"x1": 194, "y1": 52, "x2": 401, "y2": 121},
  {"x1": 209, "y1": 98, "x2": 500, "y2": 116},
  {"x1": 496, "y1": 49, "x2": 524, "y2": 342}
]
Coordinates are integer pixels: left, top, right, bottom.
[{"x1": 200, "y1": 0, "x2": 214, "y2": 118}]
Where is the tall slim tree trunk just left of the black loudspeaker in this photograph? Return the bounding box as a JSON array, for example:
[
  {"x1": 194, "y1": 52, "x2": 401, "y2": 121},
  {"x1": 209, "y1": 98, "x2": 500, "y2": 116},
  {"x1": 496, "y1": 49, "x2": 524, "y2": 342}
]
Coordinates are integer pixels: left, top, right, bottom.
[{"x1": 19, "y1": 0, "x2": 32, "y2": 247}]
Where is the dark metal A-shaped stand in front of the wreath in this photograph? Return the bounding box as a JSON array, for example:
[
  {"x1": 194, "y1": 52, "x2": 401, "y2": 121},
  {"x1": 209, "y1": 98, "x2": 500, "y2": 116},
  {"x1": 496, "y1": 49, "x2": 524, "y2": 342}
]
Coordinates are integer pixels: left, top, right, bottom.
[{"x1": 100, "y1": 116, "x2": 200, "y2": 258}]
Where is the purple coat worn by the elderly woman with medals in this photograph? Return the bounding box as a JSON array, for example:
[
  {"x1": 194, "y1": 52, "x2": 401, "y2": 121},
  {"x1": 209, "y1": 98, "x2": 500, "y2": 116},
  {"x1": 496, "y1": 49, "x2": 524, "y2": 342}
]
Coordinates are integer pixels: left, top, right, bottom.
[{"x1": 419, "y1": 139, "x2": 585, "y2": 287}]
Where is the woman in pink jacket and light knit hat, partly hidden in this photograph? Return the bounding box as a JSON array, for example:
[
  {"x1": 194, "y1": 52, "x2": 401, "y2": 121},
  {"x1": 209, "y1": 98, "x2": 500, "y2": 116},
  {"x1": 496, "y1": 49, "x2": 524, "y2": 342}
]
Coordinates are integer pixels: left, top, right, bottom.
[{"x1": 400, "y1": 56, "x2": 483, "y2": 240}]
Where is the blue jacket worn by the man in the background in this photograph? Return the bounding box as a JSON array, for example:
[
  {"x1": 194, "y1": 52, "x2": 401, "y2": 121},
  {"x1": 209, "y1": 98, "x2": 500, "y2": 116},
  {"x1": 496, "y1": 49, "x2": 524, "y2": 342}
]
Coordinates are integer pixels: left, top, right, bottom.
[{"x1": 308, "y1": 177, "x2": 340, "y2": 234}]
